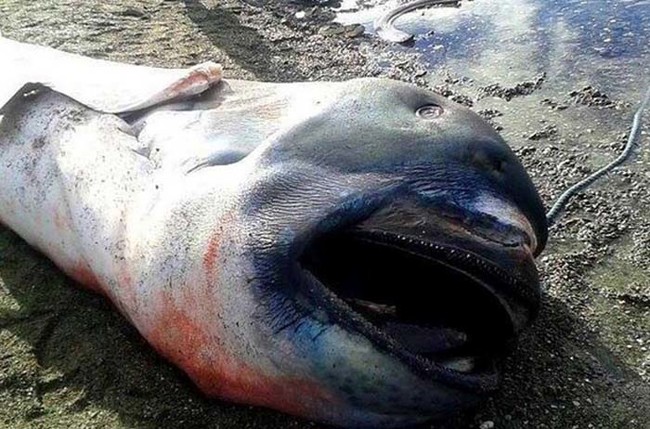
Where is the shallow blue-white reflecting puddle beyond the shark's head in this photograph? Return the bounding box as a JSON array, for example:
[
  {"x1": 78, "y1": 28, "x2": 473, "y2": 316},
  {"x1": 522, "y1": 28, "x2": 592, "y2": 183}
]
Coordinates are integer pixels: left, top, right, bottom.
[{"x1": 337, "y1": 0, "x2": 650, "y2": 102}]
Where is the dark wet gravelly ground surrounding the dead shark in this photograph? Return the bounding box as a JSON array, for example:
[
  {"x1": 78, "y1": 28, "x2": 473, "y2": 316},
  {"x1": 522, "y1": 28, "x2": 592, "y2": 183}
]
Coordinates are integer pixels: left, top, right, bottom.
[{"x1": 0, "y1": 0, "x2": 650, "y2": 429}]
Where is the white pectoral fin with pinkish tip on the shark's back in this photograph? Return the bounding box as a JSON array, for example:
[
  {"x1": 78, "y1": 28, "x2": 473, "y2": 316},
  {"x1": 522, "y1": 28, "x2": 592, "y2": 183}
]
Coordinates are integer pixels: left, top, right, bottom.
[{"x1": 0, "y1": 37, "x2": 222, "y2": 113}]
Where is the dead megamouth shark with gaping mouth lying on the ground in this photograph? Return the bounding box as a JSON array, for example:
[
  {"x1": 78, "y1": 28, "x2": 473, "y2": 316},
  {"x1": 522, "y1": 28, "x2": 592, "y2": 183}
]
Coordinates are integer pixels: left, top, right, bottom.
[{"x1": 0, "y1": 39, "x2": 547, "y2": 427}]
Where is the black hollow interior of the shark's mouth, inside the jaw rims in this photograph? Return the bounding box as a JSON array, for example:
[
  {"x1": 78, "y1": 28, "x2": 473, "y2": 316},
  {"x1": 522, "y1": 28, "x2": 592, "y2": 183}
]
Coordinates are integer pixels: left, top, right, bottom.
[{"x1": 301, "y1": 231, "x2": 513, "y2": 373}]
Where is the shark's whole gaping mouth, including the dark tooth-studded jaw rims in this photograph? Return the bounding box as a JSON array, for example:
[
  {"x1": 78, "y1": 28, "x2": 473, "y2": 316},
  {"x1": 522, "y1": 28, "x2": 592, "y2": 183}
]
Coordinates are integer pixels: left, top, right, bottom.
[{"x1": 300, "y1": 226, "x2": 537, "y2": 391}]
